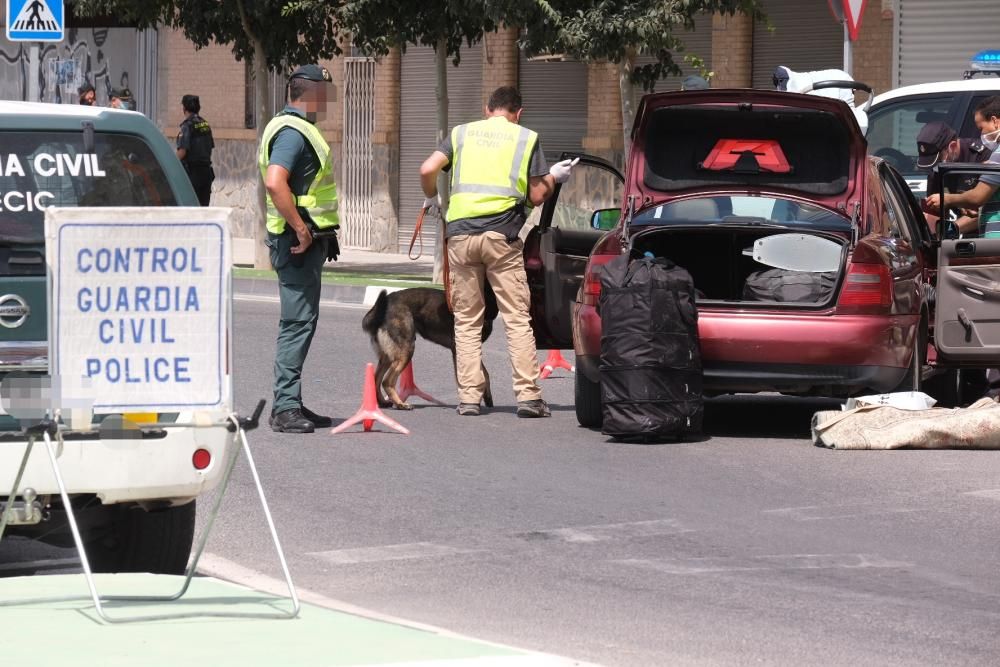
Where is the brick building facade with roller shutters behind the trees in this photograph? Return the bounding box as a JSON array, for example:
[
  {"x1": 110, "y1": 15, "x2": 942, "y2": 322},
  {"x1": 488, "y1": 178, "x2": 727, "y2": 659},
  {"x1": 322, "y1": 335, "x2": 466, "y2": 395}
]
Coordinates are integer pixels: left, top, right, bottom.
[{"x1": 0, "y1": 0, "x2": 1000, "y2": 263}]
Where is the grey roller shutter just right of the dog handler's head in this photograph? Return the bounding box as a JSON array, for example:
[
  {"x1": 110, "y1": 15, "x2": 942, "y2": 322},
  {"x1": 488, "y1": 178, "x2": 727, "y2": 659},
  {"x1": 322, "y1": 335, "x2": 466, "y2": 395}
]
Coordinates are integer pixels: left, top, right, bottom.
[{"x1": 518, "y1": 53, "x2": 587, "y2": 164}]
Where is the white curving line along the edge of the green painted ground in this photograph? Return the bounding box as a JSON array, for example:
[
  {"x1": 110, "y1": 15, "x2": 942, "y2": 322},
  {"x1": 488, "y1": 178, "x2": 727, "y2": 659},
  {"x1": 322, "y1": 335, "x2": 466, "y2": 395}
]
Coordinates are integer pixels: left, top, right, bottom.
[{"x1": 198, "y1": 553, "x2": 597, "y2": 667}]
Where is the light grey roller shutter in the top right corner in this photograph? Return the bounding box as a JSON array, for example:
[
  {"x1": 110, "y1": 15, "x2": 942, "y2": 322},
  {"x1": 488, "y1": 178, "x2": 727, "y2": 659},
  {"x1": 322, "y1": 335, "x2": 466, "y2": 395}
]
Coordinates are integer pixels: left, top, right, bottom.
[{"x1": 896, "y1": 0, "x2": 1000, "y2": 86}]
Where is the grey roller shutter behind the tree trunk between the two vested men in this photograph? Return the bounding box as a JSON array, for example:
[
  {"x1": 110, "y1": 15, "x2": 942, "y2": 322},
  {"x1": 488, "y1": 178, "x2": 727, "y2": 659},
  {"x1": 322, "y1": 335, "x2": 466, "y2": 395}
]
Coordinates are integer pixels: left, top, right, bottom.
[{"x1": 399, "y1": 44, "x2": 483, "y2": 252}]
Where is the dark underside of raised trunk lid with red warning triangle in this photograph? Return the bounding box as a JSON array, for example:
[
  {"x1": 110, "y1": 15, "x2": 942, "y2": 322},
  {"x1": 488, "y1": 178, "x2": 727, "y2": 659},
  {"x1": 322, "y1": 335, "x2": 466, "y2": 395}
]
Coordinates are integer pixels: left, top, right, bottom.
[{"x1": 643, "y1": 104, "x2": 851, "y2": 195}]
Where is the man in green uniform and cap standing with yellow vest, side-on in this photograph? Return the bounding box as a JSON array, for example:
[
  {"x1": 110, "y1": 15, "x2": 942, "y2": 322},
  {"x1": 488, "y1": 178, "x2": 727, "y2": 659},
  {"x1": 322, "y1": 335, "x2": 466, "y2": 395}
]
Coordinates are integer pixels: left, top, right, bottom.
[{"x1": 258, "y1": 65, "x2": 340, "y2": 433}]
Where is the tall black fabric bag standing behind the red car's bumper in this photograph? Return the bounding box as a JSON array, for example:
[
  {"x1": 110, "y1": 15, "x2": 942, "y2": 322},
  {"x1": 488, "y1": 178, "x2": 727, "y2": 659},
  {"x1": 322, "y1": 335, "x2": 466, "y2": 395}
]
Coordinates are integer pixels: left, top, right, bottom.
[{"x1": 599, "y1": 255, "x2": 704, "y2": 440}]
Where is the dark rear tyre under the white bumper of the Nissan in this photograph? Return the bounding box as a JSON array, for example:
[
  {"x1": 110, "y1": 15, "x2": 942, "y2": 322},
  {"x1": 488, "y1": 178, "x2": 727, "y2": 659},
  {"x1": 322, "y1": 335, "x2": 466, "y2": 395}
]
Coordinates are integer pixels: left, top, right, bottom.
[{"x1": 87, "y1": 501, "x2": 195, "y2": 574}]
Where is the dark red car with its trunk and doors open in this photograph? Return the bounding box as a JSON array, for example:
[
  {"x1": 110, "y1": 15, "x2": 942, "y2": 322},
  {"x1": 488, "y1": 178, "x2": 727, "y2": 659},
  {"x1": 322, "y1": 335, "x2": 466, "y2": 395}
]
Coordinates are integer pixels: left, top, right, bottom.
[{"x1": 524, "y1": 90, "x2": 1000, "y2": 426}]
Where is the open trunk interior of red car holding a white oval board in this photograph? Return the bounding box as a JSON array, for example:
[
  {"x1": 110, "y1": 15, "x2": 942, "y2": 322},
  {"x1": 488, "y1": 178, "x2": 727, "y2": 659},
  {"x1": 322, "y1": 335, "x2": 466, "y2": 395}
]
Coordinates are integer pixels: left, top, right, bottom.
[{"x1": 632, "y1": 225, "x2": 848, "y2": 308}]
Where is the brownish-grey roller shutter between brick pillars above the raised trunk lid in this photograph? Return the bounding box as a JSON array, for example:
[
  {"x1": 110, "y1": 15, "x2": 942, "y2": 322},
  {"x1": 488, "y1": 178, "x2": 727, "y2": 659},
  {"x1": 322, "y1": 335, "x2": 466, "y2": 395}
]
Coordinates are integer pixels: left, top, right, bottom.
[{"x1": 753, "y1": 0, "x2": 844, "y2": 88}]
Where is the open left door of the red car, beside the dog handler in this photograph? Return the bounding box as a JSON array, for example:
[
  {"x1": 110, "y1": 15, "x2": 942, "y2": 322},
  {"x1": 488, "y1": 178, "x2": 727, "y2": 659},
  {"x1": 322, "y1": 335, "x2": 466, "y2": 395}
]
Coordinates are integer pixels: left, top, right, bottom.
[{"x1": 524, "y1": 153, "x2": 625, "y2": 350}]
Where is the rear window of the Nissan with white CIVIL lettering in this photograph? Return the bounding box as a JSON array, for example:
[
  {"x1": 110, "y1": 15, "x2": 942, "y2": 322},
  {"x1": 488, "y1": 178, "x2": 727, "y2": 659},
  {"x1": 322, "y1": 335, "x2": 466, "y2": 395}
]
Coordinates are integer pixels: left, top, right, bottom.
[{"x1": 0, "y1": 130, "x2": 177, "y2": 244}]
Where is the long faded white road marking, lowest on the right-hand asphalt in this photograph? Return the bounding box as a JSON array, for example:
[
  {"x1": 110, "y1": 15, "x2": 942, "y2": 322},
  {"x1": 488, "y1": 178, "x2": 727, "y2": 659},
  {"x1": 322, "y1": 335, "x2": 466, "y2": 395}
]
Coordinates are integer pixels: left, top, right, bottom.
[{"x1": 613, "y1": 554, "x2": 913, "y2": 575}]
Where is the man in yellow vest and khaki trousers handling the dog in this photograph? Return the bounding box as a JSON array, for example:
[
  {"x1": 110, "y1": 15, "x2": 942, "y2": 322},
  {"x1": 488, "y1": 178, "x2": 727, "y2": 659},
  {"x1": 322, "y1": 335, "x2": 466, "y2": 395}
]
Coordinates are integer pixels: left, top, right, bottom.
[{"x1": 420, "y1": 86, "x2": 576, "y2": 417}]
